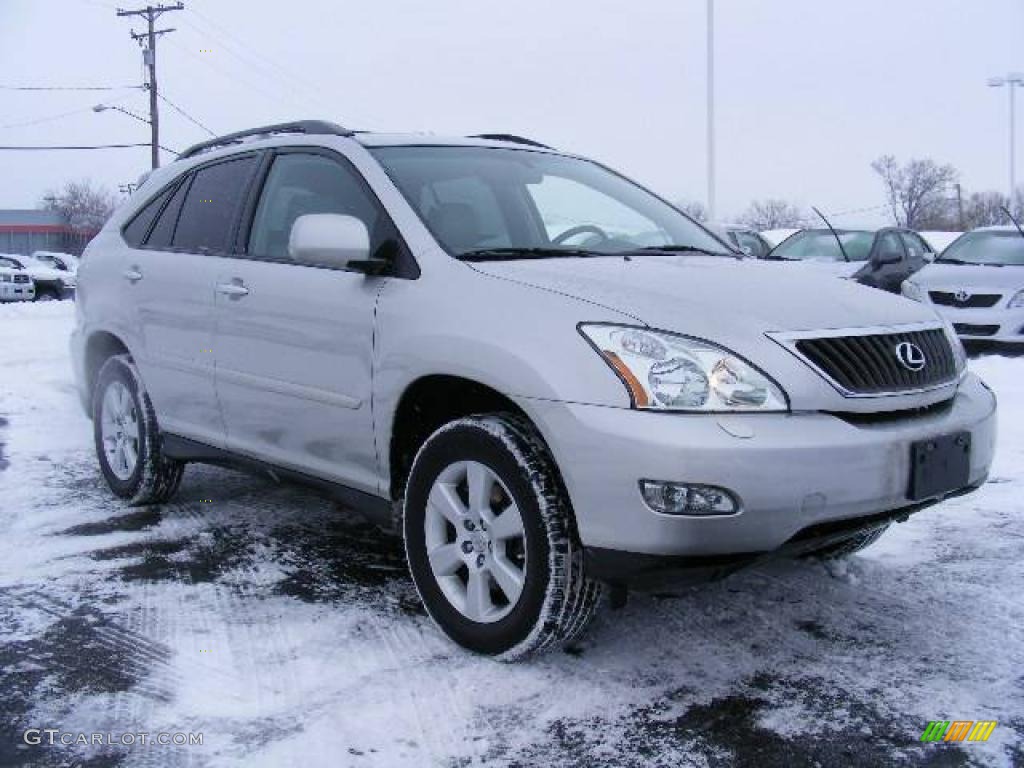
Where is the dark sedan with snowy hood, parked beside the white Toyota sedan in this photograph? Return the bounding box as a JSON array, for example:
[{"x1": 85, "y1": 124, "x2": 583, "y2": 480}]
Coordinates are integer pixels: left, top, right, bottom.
[{"x1": 768, "y1": 227, "x2": 934, "y2": 293}]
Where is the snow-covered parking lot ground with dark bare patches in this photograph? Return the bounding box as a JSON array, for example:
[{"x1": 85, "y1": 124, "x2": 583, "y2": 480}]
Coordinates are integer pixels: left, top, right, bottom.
[{"x1": 0, "y1": 302, "x2": 1024, "y2": 768}]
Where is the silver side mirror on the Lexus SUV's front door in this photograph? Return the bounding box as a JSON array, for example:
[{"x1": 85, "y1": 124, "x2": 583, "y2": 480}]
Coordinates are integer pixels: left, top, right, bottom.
[{"x1": 288, "y1": 213, "x2": 388, "y2": 274}]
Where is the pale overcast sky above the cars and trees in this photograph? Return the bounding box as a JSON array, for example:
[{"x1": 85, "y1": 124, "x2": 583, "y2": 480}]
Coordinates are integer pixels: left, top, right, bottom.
[{"x1": 0, "y1": 0, "x2": 1024, "y2": 225}]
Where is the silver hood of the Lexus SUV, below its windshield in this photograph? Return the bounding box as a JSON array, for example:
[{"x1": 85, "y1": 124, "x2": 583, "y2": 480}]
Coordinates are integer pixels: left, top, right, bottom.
[{"x1": 471, "y1": 256, "x2": 936, "y2": 340}]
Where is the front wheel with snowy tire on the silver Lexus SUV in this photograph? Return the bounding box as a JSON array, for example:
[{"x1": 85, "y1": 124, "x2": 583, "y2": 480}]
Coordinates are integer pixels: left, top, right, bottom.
[{"x1": 402, "y1": 414, "x2": 602, "y2": 660}]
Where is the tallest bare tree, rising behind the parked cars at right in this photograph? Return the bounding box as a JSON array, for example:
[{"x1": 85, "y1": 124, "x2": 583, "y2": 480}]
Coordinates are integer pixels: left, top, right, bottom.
[{"x1": 871, "y1": 155, "x2": 959, "y2": 229}]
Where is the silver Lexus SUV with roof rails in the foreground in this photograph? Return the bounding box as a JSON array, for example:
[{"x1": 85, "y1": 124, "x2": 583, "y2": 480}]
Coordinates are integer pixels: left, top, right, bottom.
[{"x1": 72, "y1": 122, "x2": 995, "y2": 658}]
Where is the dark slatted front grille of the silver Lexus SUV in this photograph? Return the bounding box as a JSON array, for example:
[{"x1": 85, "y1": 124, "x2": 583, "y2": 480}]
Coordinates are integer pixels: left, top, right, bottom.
[{"x1": 797, "y1": 329, "x2": 956, "y2": 394}]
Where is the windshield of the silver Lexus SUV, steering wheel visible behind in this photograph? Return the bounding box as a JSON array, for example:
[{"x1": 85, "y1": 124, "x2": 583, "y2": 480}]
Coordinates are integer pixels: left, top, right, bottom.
[{"x1": 371, "y1": 146, "x2": 735, "y2": 258}]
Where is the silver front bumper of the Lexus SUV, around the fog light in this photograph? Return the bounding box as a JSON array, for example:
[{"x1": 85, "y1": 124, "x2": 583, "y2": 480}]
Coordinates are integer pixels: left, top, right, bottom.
[{"x1": 519, "y1": 374, "x2": 995, "y2": 557}]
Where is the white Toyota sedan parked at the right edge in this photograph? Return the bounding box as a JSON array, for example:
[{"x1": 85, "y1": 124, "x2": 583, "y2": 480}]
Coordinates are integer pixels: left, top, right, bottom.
[{"x1": 903, "y1": 226, "x2": 1024, "y2": 344}]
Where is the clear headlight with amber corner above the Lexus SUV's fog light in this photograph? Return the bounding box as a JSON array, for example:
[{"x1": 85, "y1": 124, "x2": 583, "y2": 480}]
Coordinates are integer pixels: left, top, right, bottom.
[{"x1": 580, "y1": 324, "x2": 788, "y2": 412}]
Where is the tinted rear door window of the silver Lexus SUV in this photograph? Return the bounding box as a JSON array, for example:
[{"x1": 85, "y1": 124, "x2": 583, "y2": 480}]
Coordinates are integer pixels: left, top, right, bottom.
[{"x1": 171, "y1": 156, "x2": 256, "y2": 253}]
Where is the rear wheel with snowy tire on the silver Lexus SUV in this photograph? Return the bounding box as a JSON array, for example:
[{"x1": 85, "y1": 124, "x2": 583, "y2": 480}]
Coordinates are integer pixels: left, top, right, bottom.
[{"x1": 92, "y1": 354, "x2": 184, "y2": 506}]
